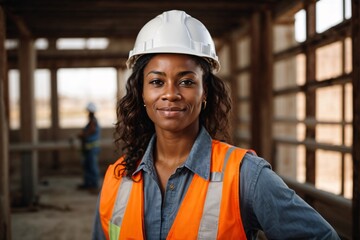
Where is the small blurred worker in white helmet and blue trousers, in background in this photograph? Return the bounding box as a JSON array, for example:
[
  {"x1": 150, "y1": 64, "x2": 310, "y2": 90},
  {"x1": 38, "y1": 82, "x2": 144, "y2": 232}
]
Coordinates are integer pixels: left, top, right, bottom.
[{"x1": 78, "y1": 102, "x2": 100, "y2": 191}]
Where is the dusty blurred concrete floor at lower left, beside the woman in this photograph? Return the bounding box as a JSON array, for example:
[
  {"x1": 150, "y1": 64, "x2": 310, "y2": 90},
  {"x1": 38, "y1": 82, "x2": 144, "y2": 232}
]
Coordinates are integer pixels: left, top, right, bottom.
[{"x1": 11, "y1": 176, "x2": 98, "y2": 240}]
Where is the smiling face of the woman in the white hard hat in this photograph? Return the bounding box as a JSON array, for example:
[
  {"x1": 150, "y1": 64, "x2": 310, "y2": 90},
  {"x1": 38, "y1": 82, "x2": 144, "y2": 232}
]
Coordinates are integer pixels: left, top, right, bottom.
[{"x1": 143, "y1": 54, "x2": 206, "y2": 133}]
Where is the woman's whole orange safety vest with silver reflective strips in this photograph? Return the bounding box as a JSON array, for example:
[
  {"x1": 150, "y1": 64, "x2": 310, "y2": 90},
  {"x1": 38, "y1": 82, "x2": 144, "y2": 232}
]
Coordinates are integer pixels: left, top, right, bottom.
[{"x1": 99, "y1": 140, "x2": 247, "y2": 240}]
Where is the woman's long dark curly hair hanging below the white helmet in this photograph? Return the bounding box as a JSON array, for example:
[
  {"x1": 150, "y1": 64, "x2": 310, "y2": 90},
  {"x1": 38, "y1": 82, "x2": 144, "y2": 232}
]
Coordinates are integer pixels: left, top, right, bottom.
[{"x1": 114, "y1": 54, "x2": 231, "y2": 178}]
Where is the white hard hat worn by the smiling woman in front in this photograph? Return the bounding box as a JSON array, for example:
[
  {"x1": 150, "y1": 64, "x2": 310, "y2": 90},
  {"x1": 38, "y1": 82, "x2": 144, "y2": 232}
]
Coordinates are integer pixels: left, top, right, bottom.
[{"x1": 126, "y1": 10, "x2": 220, "y2": 72}]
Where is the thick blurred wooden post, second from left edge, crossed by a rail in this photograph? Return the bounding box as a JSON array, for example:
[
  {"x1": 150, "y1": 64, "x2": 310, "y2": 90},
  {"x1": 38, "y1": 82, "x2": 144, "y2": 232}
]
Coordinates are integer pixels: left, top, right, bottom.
[{"x1": 18, "y1": 37, "x2": 38, "y2": 206}]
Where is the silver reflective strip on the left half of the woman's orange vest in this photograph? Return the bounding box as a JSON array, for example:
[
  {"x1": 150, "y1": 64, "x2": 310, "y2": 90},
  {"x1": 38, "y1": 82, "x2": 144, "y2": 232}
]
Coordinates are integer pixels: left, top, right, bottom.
[{"x1": 111, "y1": 177, "x2": 133, "y2": 227}]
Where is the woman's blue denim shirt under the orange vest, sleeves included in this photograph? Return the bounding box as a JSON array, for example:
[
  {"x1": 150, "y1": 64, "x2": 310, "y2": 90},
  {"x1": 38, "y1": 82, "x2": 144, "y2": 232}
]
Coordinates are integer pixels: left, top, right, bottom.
[{"x1": 93, "y1": 128, "x2": 340, "y2": 240}]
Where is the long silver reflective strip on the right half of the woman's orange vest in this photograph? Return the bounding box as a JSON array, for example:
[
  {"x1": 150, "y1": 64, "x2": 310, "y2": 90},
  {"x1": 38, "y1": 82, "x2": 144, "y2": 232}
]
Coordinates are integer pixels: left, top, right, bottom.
[{"x1": 198, "y1": 147, "x2": 235, "y2": 240}]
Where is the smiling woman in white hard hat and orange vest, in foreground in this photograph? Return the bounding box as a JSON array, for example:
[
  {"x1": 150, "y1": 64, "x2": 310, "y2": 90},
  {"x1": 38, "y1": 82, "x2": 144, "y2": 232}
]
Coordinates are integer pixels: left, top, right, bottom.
[{"x1": 93, "y1": 11, "x2": 339, "y2": 240}]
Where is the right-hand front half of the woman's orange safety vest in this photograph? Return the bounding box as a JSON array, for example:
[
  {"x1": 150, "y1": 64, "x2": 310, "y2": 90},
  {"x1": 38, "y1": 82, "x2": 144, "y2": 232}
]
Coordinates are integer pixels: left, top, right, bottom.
[{"x1": 167, "y1": 140, "x2": 247, "y2": 239}]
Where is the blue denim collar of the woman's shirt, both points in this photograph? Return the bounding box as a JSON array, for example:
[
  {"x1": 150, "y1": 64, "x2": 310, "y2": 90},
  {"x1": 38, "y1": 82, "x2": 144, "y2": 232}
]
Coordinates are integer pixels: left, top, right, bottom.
[{"x1": 133, "y1": 127, "x2": 212, "y2": 180}]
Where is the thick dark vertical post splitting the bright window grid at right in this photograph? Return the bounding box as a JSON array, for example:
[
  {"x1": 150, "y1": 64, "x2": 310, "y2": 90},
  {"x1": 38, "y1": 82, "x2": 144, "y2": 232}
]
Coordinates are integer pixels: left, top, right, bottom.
[{"x1": 305, "y1": 3, "x2": 316, "y2": 184}]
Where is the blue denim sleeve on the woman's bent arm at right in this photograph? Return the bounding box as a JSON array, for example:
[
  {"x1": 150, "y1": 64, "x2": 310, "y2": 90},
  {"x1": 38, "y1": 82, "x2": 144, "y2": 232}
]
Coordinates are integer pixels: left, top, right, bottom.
[{"x1": 240, "y1": 154, "x2": 340, "y2": 239}]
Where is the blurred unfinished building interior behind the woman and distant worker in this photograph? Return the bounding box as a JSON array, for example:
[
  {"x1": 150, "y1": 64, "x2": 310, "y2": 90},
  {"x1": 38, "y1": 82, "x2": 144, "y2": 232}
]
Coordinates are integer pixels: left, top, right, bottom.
[{"x1": 0, "y1": 0, "x2": 360, "y2": 240}]
